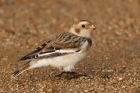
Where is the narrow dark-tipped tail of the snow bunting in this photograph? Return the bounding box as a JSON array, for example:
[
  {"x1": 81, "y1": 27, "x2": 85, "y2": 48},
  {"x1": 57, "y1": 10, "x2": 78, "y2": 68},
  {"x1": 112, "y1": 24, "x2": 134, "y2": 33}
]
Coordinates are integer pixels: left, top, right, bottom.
[{"x1": 12, "y1": 62, "x2": 30, "y2": 78}]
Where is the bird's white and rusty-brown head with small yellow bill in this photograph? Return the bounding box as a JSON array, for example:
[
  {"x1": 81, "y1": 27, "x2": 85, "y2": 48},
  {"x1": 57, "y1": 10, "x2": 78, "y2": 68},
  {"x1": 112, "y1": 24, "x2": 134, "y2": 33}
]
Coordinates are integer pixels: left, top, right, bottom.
[{"x1": 70, "y1": 20, "x2": 95, "y2": 37}]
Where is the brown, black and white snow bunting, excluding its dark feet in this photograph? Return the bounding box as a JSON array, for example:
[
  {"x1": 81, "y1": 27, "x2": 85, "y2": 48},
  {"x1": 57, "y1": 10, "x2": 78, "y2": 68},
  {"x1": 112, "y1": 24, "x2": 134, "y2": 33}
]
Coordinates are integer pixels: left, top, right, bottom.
[{"x1": 12, "y1": 20, "x2": 95, "y2": 77}]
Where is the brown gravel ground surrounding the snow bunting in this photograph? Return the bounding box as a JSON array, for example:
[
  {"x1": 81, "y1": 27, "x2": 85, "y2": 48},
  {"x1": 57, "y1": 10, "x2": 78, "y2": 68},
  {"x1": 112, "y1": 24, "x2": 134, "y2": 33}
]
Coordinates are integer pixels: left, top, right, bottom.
[{"x1": 0, "y1": 0, "x2": 140, "y2": 93}]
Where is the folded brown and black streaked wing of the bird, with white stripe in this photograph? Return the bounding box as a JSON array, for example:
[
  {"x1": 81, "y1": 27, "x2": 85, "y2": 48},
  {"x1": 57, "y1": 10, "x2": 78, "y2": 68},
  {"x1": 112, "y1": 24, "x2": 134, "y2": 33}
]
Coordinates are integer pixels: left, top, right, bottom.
[{"x1": 19, "y1": 32, "x2": 86, "y2": 61}]
